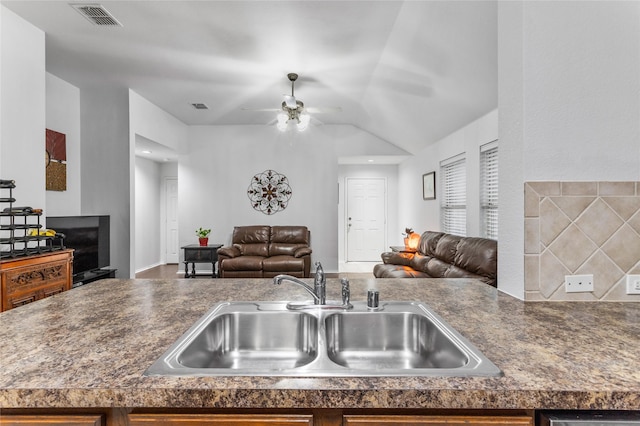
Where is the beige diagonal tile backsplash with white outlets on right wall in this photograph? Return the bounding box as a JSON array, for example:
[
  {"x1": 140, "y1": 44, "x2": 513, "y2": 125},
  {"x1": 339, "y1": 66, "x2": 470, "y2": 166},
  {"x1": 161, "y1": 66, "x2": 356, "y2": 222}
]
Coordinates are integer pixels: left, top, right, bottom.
[{"x1": 524, "y1": 182, "x2": 640, "y2": 302}]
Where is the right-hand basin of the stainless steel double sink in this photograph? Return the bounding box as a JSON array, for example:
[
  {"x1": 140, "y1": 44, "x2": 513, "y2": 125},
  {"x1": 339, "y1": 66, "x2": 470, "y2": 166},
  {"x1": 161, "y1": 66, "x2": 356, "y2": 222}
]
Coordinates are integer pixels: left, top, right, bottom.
[{"x1": 326, "y1": 312, "x2": 469, "y2": 370}]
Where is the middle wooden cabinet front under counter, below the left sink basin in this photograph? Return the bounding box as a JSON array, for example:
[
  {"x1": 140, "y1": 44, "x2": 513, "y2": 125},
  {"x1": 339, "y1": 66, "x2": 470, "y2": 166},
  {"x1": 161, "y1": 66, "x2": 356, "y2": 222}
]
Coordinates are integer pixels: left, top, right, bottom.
[{"x1": 129, "y1": 414, "x2": 313, "y2": 426}]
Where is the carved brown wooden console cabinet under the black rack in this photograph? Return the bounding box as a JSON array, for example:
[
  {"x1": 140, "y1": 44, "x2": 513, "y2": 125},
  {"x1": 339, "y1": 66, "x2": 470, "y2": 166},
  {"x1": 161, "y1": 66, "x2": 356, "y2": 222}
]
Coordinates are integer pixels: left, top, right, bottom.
[{"x1": 0, "y1": 250, "x2": 73, "y2": 311}]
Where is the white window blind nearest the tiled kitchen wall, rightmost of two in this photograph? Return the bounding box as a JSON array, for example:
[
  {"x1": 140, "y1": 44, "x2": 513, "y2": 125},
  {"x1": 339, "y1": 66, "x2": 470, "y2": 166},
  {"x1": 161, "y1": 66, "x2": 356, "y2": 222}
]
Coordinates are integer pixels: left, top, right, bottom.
[{"x1": 480, "y1": 143, "x2": 498, "y2": 240}]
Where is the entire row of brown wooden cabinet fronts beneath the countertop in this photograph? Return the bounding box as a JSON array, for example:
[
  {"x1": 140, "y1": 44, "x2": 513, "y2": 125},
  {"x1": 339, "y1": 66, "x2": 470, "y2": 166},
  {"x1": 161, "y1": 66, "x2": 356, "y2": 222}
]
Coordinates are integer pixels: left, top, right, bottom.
[{"x1": 0, "y1": 408, "x2": 535, "y2": 426}]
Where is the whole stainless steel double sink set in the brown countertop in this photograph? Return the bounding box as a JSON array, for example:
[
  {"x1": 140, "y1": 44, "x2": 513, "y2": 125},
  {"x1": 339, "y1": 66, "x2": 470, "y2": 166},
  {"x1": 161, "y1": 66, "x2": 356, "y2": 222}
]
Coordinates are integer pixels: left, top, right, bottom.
[{"x1": 145, "y1": 302, "x2": 502, "y2": 377}]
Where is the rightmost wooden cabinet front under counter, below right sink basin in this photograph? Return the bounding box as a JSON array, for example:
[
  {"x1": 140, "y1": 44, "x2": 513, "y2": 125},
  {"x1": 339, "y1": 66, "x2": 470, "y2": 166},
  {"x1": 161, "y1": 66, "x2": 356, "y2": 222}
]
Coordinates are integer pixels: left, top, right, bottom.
[{"x1": 343, "y1": 415, "x2": 533, "y2": 426}]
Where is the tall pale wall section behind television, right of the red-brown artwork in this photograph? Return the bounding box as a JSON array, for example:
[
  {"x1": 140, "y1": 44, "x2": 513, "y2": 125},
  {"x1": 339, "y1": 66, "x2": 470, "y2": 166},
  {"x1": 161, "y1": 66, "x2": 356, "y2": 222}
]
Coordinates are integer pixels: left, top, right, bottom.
[{"x1": 80, "y1": 87, "x2": 134, "y2": 278}]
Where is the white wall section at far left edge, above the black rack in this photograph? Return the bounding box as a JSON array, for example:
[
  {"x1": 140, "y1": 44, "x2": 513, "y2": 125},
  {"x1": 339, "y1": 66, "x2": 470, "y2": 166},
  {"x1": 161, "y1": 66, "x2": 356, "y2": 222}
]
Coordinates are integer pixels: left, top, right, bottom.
[{"x1": 0, "y1": 6, "x2": 45, "y2": 209}]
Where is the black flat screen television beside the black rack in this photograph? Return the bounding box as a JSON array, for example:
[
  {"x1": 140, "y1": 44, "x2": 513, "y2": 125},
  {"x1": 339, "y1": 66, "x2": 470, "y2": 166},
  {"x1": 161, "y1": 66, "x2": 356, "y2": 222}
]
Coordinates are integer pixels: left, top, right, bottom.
[{"x1": 46, "y1": 216, "x2": 110, "y2": 277}]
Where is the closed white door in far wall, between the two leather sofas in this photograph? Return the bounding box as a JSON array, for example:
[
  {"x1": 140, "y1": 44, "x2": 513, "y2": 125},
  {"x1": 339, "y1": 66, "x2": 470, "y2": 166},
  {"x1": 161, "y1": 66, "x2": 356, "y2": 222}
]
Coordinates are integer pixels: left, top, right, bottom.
[{"x1": 345, "y1": 178, "x2": 387, "y2": 262}]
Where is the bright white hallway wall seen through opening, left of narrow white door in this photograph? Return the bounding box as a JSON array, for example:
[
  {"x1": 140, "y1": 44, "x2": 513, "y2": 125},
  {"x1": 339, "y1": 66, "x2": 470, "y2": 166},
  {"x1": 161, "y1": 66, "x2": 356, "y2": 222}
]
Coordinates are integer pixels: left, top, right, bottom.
[{"x1": 135, "y1": 157, "x2": 162, "y2": 272}]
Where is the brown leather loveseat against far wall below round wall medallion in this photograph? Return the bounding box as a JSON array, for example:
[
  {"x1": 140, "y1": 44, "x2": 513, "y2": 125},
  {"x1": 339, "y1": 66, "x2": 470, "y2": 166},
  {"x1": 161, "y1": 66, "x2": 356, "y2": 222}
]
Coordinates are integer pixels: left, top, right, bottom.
[{"x1": 218, "y1": 226, "x2": 311, "y2": 278}]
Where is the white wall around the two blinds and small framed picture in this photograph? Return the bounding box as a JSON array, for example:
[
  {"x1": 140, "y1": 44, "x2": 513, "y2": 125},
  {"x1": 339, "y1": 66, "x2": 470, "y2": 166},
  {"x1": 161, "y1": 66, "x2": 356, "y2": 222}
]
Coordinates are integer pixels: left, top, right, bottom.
[{"x1": 398, "y1": 111, "x2": 502, "y2": 240}]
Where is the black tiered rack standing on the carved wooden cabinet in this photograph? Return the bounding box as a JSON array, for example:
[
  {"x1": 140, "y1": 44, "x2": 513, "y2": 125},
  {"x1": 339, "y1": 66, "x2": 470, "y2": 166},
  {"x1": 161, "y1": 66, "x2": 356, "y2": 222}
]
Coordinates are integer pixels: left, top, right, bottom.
[{"x1": 0, "y1": 179, "x2": 65, "y2": 259}]
